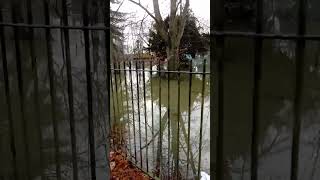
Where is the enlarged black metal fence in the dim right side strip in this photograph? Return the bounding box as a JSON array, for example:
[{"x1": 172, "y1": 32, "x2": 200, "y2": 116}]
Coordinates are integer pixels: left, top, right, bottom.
[{"x1": 210, "y1": 0, "x2": 319, "y2": 180}]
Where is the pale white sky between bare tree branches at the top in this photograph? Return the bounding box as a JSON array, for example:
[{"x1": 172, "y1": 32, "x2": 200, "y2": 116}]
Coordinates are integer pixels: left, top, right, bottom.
[{"x1": 111, "y1": 0, "x2": 210, "y2": 52}]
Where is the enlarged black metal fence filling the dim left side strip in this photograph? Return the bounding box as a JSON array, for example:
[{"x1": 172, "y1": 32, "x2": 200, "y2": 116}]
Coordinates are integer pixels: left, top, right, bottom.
[{"x1": 0, "y1": 0, "x2": 110, "y2": 180}]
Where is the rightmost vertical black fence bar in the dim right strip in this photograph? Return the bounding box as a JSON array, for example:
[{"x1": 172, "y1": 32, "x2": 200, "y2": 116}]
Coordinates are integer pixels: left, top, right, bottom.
[{"x1": 291, "y1": 0, "x2": 307, "y2": 180}]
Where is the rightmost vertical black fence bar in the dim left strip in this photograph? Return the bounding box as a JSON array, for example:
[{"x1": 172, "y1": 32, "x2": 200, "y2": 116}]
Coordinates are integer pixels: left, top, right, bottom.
[{"x1": 82, "y1": 0, "x2": 96, "y2": 180}]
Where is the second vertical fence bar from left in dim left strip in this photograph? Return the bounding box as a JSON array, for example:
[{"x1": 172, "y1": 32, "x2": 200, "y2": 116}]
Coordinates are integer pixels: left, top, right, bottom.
[{"x1": 11, "y1": 1, "x2": 31, "y2": 179}]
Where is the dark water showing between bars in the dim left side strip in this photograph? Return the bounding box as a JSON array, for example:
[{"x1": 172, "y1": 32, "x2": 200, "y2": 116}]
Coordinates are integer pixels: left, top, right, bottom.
[{"x1": 0, "y1": 29, "x2": 108, "y2": 179}]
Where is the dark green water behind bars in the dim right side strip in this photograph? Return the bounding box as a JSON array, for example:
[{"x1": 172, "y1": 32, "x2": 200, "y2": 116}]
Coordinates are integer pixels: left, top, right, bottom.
[{"x1": 219, "y1": 38, "x2": 319, "y2": 179}]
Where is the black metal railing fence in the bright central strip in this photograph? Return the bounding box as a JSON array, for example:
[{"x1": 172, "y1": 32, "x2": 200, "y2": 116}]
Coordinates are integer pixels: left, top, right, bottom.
[{"x1": 111, "y1": 57, "x2": 210, "y2": 179}]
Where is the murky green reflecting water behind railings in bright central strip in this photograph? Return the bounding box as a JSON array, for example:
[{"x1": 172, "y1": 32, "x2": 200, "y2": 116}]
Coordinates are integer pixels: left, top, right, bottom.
[{"x1": 112, "y1": 63, "x2": 210, "y2": 177}]
